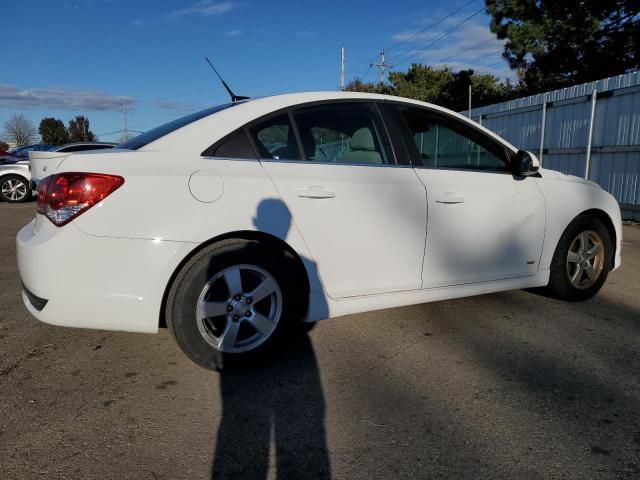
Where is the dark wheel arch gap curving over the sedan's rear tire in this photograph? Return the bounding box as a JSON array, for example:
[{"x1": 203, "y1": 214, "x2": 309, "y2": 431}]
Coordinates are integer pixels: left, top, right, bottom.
[{"x1": 158, "y1": 230, "x2": 310, "y2": 328}]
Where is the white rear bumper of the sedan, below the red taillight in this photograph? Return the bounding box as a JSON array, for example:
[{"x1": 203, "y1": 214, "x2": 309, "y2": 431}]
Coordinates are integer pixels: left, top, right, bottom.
[{"x1": 16, "y1": 217, "x2": 195, "y2": 333}]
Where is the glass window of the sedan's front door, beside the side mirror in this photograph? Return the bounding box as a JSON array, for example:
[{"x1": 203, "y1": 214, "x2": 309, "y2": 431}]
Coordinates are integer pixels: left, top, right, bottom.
[{"x1": 399, "y1": 106, "x2": 507, "y2": 171}]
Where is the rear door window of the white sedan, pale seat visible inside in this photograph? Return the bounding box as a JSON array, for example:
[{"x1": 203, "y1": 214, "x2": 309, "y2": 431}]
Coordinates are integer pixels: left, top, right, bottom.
[{"x1": 293, "y1": 102, "x2": 392, "y2": 165}]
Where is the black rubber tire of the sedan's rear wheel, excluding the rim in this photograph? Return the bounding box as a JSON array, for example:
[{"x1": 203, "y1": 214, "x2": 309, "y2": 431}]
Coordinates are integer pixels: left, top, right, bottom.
[{"x1": 165, "y1": 239, "x2": 305, "y2": 370}]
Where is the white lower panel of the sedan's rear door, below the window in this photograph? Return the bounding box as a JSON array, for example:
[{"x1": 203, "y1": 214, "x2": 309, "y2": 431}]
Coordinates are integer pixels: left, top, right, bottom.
[{"x1": 263, "y1": 161, "x2": 427, "y2": 298}]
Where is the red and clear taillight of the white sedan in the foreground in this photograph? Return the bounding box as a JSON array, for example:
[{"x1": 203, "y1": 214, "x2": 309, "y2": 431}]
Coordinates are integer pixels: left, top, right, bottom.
[{"x1": 38, "y1": 172, "x2": 124, "y2": 227}]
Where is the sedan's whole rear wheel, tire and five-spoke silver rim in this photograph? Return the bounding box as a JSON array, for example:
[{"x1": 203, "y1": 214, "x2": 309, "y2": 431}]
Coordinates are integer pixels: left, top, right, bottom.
[{"x1": 165, "y1": 240, "x2": 303, "y2": 369}]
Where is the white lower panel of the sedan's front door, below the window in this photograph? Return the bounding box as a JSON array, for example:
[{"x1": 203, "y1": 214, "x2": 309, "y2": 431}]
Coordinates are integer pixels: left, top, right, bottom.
[{"x1": 416, "y1": 168, "x2": 545, "y2": 287}]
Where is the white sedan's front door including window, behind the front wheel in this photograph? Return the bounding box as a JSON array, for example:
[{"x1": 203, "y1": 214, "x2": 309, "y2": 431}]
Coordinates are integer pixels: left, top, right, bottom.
[{"x1": 395, "y1": 105, "x2": 545, "y2": 288}]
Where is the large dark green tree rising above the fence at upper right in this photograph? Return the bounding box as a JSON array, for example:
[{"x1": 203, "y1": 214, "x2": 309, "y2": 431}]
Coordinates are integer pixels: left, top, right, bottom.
[{"x1": 486, "y1": 0, "x2": 640, "y2": 93}]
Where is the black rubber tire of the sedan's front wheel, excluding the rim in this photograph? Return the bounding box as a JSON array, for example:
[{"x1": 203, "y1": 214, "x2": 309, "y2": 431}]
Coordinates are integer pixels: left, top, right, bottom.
[{"x1": 547, "y1": 215, "x2": 613, "y2": 302}]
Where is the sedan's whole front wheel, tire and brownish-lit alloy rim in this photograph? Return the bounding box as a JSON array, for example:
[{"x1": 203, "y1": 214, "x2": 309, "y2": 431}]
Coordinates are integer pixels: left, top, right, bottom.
[{"x1": 547, "y1": 215, "x2": 613, "y2": 301}]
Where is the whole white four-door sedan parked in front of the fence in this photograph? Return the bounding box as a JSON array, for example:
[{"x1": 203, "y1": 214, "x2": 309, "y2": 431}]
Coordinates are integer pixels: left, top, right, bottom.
[{"x1": 17, "y1": 92, "x2": 622, "y2": 368}]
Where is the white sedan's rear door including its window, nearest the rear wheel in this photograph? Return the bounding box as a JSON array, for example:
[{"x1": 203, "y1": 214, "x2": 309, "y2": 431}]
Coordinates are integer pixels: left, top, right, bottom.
[{"x1": 251, "y1": 102, "x2": 427, "y2": 298}]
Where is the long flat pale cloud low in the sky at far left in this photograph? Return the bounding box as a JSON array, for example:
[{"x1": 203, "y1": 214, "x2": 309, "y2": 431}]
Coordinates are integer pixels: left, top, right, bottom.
[{"x1": 0, "y1": 84, "x2": 135, "y2": 112}]
